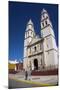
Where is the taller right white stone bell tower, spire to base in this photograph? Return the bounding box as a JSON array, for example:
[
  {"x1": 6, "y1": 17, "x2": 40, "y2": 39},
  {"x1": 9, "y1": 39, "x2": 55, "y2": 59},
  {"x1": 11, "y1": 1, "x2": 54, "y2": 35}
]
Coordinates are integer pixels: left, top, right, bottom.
[{"x1": 41, "y1": 9, "x2": 58, "y2": 66}]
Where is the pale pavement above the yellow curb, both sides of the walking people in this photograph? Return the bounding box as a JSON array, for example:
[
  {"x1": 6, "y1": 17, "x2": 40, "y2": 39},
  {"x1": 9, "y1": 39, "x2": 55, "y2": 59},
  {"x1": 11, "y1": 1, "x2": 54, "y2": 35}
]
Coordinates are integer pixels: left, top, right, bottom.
[{"x1": 9, "y1": 72, "x2": 58, "y2": 85}]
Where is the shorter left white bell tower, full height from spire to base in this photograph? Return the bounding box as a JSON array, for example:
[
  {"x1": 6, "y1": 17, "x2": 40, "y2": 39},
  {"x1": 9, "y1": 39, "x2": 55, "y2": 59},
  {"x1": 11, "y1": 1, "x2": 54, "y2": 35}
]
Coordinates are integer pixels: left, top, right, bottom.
[{"x1": 24, "y1": 19, "x2": 35, "y2": 68}]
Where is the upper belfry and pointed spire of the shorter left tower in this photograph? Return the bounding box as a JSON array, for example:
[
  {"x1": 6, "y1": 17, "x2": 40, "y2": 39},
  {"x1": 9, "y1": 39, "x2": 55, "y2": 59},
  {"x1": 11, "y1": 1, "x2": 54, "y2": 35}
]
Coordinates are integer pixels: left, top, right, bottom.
[{"x1": 24, "y1": 19, "x2": 35, "y2": 46}]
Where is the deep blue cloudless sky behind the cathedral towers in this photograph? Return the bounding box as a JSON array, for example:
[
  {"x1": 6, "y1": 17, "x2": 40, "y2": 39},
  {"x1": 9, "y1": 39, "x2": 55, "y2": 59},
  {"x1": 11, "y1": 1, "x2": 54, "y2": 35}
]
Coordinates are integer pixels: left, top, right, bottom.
[{"x1": 9, "y1": 1, "x2": 58, "y2": 60}]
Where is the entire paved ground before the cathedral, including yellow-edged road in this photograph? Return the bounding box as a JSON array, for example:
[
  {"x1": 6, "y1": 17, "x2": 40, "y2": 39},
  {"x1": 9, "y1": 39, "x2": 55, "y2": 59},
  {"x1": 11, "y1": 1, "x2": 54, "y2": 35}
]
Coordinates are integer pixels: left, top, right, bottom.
[{"x1": 9, "y1": 72, "x2": 58, "y2": 88}]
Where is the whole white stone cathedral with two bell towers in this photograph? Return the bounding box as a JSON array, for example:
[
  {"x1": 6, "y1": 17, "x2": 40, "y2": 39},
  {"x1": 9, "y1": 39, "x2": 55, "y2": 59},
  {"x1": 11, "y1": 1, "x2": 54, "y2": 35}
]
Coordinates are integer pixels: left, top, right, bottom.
[{"x1": 23, "y1": 9, "x2": 58, "y2": 70}]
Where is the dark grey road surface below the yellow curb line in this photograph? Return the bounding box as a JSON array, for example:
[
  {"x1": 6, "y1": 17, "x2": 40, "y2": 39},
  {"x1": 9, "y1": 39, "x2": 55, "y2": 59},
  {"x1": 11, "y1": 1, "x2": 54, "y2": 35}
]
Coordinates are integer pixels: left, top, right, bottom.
[{"x1": 8, "y1": 79, "x2": 40, "y2": 89}]
